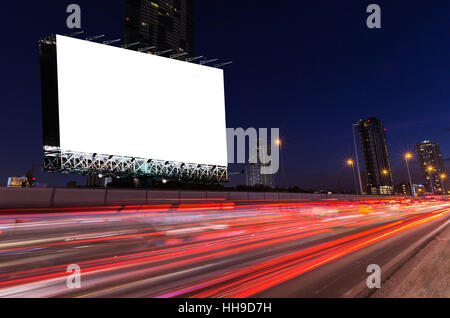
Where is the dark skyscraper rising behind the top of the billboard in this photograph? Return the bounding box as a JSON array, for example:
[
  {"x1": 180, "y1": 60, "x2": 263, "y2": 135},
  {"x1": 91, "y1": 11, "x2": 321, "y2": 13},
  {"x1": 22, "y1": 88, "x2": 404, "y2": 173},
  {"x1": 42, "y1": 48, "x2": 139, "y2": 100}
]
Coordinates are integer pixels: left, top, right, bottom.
[{"x1": 124, "y1": 0, "x2": 195, "y2": 55}]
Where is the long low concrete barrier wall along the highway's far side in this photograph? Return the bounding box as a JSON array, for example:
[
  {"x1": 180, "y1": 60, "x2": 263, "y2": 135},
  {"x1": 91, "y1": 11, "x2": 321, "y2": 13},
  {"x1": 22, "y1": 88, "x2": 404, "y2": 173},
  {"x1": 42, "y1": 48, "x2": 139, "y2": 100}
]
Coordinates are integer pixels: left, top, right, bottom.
[{"x1": 0, "y1": 187, "x2": 442, "y2": 209}]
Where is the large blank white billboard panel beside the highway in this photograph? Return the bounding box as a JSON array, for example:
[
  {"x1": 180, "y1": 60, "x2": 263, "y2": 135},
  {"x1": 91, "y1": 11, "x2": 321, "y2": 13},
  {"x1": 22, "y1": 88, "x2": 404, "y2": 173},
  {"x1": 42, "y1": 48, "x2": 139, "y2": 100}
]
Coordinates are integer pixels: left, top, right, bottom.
[{"x1": 56, "y1": 35, "x2": 227, "y2": 166}]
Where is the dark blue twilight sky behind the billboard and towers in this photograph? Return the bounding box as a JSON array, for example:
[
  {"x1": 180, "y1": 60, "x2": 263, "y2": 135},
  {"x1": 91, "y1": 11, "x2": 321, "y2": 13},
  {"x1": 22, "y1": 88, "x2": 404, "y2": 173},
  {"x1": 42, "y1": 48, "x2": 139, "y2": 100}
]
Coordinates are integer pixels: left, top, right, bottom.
[{"x1": 0, "y1": 0, "x2": 450, "y2": 189}]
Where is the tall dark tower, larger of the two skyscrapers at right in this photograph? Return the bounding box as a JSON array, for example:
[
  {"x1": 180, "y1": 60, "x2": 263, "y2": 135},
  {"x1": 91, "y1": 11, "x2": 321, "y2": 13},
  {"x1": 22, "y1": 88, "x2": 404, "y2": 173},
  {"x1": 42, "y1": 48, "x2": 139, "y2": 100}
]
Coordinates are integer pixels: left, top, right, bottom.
[{"x1": 358, "y1": 118, "x2": 394, "y2": 194}]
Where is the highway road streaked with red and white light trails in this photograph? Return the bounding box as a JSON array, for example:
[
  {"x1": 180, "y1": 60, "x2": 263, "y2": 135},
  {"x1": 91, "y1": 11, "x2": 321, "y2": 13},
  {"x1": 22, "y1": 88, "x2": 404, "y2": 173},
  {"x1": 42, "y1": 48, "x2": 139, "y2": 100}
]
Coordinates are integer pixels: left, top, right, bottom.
[{"x1": 0, "y1": 199, "x2": 450, "y2": 298}]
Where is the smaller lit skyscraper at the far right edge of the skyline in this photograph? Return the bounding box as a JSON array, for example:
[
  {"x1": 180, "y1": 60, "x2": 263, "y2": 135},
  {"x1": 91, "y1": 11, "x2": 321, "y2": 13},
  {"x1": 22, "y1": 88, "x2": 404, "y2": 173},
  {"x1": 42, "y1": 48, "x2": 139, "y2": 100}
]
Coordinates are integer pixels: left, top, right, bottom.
[{"x1": 416, "y1": 140, "x2": 449, "y2": 194}]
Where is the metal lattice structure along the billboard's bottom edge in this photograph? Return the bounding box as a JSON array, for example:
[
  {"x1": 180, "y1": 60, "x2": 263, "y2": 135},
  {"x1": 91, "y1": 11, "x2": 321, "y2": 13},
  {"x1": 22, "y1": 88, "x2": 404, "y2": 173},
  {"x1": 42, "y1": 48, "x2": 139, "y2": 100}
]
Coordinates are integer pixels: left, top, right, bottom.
[{"x1": 43, "y1": 146, "x2": 228, "y2": 183}]
